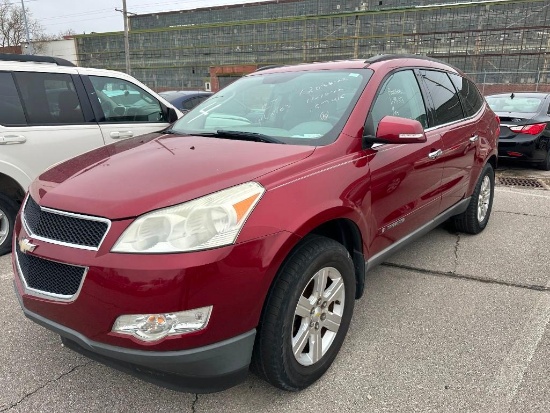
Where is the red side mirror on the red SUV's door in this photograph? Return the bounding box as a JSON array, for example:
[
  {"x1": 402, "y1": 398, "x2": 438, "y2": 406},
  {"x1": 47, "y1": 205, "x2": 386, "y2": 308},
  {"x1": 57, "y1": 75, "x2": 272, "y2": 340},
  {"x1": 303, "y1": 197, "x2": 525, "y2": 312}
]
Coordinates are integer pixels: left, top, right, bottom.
[{"x1": 363, "y1": 116, "x2": 426, "y2": 145}]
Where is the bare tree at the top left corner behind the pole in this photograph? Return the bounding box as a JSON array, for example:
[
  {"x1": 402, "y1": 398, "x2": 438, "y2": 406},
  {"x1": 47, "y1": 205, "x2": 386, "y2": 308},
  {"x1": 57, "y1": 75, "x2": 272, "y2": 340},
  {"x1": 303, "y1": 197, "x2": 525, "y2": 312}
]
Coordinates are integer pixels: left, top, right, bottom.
[{"x1": 0, "y1": 0, "x2": 44, "y2": 47}]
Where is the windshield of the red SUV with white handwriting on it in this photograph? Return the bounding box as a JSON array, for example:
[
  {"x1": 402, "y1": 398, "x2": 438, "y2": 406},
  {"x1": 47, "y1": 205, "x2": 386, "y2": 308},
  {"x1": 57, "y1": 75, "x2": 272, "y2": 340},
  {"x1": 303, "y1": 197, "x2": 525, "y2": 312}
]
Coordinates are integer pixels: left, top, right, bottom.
[{"x1": 172, "y1": 69, "x2": 372, "y2": 146}]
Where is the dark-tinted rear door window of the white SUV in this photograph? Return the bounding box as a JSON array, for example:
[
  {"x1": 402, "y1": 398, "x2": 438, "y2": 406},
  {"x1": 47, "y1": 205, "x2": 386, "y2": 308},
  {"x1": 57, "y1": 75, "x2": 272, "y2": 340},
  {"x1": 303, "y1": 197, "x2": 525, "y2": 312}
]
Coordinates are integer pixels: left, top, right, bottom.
[{"x1": 14, "y1": 72, "x2": 84, "y2": 125}]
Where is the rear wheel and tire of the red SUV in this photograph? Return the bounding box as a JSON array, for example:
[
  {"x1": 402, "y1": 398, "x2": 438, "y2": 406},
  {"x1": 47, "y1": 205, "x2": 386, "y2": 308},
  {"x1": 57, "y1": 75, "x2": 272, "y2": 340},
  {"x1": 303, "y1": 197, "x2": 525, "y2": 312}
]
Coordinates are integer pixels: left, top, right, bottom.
[{"x1": 452, "y1": 164, "x2": 495, "y2": 234}]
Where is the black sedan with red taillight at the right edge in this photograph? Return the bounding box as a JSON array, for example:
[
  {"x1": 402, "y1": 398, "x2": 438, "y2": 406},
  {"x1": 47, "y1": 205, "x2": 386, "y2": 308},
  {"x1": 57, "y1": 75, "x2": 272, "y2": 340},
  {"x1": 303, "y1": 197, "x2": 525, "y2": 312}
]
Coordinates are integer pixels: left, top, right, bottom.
[{"x1": 486, "y1": 92, "x2": 550, "y2": 171}]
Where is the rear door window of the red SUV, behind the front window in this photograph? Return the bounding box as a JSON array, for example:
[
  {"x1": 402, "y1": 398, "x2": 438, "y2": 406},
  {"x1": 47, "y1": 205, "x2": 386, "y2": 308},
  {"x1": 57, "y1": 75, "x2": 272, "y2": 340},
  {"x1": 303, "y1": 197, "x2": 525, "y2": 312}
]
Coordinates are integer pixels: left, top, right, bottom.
[{"x1": 420, "y1": 70, "x2": 464, "y2": 126}]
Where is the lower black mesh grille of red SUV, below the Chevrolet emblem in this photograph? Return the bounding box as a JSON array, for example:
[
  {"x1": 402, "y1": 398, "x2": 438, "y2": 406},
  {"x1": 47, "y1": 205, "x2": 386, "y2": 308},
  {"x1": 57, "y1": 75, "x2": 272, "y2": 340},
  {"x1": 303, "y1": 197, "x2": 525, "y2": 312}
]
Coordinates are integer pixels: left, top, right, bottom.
[{"x1": 16, "y1": 248, "x2": 87, "y2": 299}]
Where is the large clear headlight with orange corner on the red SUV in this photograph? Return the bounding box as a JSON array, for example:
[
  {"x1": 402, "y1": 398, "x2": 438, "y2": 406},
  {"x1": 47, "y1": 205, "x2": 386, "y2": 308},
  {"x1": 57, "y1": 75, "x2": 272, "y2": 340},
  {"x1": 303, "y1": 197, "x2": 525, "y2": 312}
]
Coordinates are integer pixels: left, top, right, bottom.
[{"x1": 112, "y1": 182, "x2": 265, "y2": 254}]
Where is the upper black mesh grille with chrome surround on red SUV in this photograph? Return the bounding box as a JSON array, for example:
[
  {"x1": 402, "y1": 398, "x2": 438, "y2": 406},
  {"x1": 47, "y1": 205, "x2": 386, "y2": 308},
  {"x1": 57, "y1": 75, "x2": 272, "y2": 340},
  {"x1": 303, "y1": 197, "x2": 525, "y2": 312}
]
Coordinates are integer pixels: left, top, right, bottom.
[{"x1": 23, "y1": 196, "x2": 109, "y2": 249}]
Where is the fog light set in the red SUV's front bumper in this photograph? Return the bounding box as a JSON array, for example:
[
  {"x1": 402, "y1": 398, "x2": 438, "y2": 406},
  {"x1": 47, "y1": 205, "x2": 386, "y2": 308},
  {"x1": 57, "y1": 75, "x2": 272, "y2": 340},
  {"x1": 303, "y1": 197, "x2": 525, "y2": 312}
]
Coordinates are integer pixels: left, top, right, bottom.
[{"x1": 112, "y1": 306, "x2": 212, "y2": 342}]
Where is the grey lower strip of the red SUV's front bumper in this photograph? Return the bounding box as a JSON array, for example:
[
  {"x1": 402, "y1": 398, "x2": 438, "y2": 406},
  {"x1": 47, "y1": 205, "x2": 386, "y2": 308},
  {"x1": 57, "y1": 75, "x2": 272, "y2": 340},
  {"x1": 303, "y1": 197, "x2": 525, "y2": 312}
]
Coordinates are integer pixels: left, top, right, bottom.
[{"x1": 18, "y1": 295, "x2": 256, "y2": 393}]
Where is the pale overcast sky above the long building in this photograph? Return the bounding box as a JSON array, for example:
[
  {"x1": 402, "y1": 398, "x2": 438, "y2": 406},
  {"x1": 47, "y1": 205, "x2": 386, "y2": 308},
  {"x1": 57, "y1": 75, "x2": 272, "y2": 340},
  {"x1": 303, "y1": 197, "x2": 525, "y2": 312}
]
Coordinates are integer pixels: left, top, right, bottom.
[{"x1": 27, "y1": 0, "x2": 259, "y2": 34}]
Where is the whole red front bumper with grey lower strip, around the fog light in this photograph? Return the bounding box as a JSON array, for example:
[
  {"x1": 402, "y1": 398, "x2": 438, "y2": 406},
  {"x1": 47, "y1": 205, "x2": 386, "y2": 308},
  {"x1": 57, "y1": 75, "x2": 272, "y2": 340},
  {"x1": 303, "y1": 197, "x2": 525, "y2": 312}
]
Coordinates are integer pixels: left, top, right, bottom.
[{"x1": 13, "y1": 209, "x2": 298, "y2": 392}]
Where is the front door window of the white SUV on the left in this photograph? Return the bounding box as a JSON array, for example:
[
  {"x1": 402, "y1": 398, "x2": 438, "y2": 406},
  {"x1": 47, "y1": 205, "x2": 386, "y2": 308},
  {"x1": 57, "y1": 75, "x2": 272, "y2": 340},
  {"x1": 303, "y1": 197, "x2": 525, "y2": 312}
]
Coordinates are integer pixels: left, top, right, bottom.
[{"x1": 89, "y1": 76, "x2": 167, "y2": 123}]
